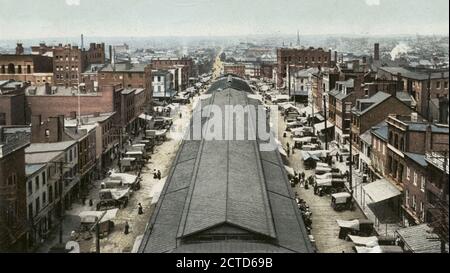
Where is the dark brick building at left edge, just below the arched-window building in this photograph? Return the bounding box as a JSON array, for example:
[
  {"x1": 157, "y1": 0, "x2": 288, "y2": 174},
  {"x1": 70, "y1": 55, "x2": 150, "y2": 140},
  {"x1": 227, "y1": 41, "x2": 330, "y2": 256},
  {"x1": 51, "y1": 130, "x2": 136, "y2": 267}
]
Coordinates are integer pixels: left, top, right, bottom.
[{"x1": 0, "y1": 80, "x2": 29, "y2": 126}]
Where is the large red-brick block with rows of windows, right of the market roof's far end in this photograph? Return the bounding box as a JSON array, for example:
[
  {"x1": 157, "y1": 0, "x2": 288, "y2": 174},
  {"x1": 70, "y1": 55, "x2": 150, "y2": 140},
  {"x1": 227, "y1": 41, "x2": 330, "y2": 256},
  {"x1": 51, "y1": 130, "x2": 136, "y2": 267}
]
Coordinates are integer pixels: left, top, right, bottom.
[{"x1": 277, "y1": 47, "x2": 333, "y2": 87}]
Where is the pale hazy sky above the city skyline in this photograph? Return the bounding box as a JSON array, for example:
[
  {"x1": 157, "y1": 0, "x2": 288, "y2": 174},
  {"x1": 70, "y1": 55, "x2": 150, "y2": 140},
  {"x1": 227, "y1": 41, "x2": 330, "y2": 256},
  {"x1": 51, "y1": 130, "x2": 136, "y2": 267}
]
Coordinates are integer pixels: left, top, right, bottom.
[{"x1": 0, "y1": 0, "x2": 449, "y2": 39}]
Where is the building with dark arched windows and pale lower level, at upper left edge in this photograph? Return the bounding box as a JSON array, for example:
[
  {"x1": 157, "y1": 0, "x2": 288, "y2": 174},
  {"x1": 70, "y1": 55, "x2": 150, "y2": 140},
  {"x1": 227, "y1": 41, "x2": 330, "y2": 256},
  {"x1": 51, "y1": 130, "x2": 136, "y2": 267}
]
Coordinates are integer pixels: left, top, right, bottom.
[{"x1": 0, "y1": 51, "x2": 53, "y2": 85}]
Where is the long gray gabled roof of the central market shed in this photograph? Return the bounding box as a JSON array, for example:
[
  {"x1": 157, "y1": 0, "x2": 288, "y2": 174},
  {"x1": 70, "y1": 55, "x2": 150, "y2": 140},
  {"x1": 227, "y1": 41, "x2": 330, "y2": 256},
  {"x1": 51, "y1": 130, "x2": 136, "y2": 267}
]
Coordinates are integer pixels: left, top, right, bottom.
[{"x1": 139, "y1": 76, "x2": 312, "y2": 252}]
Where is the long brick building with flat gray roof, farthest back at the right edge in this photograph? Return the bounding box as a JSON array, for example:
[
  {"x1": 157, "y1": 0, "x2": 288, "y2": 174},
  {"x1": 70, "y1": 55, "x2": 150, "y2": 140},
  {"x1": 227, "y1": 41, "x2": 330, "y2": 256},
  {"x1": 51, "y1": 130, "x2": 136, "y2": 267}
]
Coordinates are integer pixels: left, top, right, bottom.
[{"x1": 377, "y1": 67, "x2": 449, "y2": 121}]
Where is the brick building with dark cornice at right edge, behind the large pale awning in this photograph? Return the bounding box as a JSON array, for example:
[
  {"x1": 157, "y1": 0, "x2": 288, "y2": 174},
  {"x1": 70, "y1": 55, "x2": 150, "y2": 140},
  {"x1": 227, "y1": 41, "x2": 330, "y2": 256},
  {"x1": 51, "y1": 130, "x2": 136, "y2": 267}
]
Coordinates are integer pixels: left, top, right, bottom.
[{"x1": 385, "y1": 113, "x2": 449, "y2": 225}]
